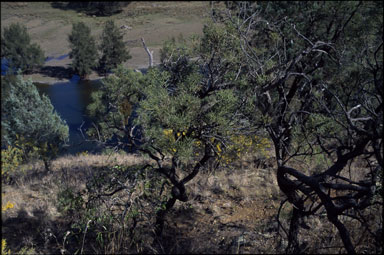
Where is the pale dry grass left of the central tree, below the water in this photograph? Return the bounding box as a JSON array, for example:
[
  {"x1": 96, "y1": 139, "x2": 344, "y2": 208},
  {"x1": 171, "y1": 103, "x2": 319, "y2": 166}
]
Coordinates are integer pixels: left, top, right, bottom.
[{"x1": 2, "y1": 151, "x2": 152, "y2": 254}]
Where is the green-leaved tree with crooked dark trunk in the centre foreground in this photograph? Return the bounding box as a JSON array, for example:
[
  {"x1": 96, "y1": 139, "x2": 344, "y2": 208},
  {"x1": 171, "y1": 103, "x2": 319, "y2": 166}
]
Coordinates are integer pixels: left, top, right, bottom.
[{"x1": 89, "y1": 22, "x2": 254, "y2": 236}]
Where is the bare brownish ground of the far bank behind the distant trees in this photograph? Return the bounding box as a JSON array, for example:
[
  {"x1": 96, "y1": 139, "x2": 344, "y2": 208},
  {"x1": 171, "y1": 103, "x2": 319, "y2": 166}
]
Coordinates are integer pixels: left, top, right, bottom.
[{"x1": 1, "y1": 1, "x2": 209, "y2": 83}]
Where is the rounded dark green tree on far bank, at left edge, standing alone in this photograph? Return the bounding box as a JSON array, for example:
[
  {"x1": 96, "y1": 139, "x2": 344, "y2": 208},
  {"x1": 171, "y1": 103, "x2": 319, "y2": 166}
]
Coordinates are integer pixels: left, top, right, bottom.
[{"x1": 1, "y1": 23, "x2": 44, "y2": 73}]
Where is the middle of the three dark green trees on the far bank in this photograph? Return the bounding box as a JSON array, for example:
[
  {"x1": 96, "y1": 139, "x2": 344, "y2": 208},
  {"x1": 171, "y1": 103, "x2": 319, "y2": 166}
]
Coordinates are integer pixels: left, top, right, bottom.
[{"x1": 68, "y1": 22, "x2": 98, "y2": 79}]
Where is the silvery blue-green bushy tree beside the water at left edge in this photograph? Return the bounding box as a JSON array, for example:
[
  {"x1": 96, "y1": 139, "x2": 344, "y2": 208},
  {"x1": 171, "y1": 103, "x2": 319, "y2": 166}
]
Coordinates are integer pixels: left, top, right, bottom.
[{"x1": 1, "y1": 75, "x2": 69, "y2": 171}]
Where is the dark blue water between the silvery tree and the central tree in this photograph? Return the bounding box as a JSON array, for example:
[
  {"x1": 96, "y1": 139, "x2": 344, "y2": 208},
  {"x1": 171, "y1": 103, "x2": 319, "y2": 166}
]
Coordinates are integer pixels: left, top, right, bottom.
[{"x1": 35, "y1": 76, "x2": 101, "y2": 154}]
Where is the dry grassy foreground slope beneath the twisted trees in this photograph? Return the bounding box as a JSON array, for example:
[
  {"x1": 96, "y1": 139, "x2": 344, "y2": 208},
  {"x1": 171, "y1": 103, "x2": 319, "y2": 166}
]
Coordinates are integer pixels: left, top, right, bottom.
[{"x1": 2, "y1": 149, "x2": 380, "y2": 254}]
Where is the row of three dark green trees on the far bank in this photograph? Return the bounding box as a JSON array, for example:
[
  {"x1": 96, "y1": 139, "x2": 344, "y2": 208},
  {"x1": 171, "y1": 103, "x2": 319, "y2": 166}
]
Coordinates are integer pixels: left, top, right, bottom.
[{"x1": 1, "y1": 21, "x2": 131, "y2": 78}]
